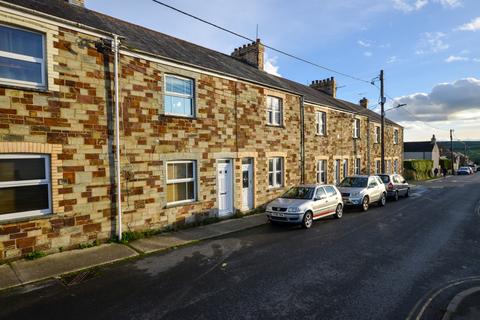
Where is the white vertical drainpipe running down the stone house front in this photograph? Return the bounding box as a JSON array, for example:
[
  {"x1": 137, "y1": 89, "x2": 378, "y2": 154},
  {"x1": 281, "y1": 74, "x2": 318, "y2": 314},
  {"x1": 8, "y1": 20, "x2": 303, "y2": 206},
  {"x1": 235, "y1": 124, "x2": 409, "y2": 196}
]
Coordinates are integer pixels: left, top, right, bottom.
[{"x1": 112, "y1": 35, "x2": 122, "y2": 241}]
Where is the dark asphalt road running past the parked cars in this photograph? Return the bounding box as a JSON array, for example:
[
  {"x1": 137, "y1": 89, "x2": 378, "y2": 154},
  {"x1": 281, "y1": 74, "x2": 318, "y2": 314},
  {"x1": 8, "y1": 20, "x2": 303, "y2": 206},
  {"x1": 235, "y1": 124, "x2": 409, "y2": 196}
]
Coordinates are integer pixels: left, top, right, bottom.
[{"x1": 0, "y1": 174, "x2": 480, "y2": 319}]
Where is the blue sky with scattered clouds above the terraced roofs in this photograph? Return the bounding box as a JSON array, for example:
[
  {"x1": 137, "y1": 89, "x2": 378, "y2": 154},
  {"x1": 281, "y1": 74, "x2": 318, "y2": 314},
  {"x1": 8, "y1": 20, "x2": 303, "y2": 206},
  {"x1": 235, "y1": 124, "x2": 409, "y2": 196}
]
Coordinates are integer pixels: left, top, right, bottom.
[{"x1": 86, "y1": 0, "x2": 480, "y2": 140}]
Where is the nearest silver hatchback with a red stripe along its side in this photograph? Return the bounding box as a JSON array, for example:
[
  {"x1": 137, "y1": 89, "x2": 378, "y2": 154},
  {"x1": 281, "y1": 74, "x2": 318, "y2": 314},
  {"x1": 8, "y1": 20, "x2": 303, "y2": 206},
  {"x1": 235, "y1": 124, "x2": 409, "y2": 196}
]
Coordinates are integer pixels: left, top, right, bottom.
[{"x1": 266, "y1": 184, "x2": 343, "y2": 229}]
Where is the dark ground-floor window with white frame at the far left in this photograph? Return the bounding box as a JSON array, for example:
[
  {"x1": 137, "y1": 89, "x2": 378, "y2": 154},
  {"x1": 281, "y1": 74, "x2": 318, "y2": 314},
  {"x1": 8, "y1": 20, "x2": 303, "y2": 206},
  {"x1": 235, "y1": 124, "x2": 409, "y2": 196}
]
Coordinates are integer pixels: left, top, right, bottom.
[{"x1": 0, "y1": 154, "x2": 52, "y2": 221}]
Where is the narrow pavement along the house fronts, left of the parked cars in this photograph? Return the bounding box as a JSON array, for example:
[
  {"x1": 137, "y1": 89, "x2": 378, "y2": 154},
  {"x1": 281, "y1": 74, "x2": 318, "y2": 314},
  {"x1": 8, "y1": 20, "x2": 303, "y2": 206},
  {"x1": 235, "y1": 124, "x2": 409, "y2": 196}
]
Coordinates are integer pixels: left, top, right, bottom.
[{"x1": 0, "y1": 214, "x2": 267, "y2": 291}]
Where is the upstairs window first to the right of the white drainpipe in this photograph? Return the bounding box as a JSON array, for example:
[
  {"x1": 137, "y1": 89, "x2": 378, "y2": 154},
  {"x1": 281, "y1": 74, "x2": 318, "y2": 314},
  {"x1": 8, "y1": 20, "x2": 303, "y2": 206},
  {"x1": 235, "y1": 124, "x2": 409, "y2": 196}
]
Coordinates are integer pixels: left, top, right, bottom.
[{"x1": 164, "y1": 75, "x2": 195, "y2": 118}]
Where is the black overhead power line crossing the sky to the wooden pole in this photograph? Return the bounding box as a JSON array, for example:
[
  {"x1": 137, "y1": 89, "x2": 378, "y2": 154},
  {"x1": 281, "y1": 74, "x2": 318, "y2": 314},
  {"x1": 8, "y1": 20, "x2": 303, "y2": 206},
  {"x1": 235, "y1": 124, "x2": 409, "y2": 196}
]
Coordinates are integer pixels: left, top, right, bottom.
[{"x1": 152, "y1": 0, "x2": 371, "y2": 84}]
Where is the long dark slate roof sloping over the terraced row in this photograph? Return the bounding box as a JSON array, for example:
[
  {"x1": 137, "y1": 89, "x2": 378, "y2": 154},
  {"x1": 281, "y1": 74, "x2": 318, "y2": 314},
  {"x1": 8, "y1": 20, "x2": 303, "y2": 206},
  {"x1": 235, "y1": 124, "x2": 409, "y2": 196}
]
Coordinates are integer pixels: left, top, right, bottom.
[{"x1": 0, "y1": 0, "x2": 399, "y2": 126}]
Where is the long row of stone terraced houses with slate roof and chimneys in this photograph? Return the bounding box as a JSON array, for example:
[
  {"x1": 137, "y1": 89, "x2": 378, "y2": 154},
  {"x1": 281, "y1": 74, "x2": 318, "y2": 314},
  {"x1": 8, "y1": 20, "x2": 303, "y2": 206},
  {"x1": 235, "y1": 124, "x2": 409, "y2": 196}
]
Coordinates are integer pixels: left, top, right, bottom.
[{"x1": 0, "y1": 0, "x2": 403, "y2": 261}]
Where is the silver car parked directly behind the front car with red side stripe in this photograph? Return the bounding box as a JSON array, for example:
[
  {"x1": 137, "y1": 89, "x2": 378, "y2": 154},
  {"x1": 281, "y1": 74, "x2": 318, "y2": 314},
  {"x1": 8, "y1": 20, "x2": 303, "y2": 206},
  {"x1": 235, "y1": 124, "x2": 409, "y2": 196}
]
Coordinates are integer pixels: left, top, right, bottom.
[{"x1": 338, "y1": 176, "x2": 387, "y2": 211}]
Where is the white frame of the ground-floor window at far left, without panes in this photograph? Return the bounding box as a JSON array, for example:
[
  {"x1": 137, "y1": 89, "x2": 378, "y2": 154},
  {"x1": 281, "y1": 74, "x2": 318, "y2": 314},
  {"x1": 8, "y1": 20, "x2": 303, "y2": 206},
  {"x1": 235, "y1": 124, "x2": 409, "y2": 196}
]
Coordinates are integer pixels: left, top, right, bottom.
[{"x1": 0, "y1": 153, "x2": 52, "y2": 221}]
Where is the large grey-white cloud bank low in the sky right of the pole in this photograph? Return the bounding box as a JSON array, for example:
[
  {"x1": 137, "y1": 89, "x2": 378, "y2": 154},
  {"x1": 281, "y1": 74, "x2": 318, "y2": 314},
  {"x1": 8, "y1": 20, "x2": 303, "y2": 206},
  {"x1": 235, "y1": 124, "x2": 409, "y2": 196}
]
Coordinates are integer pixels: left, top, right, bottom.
[{"x1": 389, "y1": 78, "x2": 480, "y2": 122}]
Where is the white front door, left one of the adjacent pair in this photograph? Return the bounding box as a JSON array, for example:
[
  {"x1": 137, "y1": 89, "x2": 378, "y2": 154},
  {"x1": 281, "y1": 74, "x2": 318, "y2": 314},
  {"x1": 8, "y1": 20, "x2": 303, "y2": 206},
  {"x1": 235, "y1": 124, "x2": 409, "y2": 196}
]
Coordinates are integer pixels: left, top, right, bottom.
[{"x1": 217, "y1": 160, "x2": 233, "y2": 217}]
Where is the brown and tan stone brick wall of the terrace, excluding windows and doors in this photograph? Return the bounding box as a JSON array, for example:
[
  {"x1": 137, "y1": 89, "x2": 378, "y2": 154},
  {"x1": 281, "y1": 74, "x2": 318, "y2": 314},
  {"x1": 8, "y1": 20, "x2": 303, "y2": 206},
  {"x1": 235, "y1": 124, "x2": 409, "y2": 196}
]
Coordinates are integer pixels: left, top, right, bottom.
[{"x1": 0, "y1": 7, "x2": 403, "y2": 261}]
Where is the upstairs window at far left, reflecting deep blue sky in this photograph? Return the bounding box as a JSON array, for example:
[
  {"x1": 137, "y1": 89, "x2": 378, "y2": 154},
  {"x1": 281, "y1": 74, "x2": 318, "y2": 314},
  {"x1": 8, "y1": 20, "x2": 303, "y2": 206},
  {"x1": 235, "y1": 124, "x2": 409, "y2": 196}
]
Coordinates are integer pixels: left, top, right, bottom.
[{"x1": 0, "y1": 25, "x2": 46, "y2": 88}]
